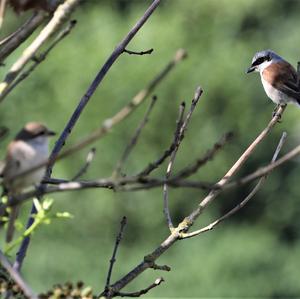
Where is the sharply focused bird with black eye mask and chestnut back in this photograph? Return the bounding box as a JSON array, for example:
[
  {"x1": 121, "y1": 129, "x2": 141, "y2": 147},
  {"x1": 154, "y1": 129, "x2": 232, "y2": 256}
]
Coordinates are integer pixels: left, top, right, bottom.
[{"x1": 247, "y1": 50, "x2": 300, "y2": 106}]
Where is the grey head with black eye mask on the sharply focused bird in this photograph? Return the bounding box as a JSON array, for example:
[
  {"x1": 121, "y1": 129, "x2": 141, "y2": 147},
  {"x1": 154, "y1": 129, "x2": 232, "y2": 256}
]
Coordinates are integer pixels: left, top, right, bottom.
[{"x1": 247, "y1": 50, "x2": 283, "y2": 73}]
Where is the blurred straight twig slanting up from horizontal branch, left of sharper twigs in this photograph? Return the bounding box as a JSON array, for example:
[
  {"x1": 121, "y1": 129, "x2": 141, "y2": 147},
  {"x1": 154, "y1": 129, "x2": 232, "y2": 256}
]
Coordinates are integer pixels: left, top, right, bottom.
[{"x1": 112, "y1": 96, "x2": 157, "y2": 177}]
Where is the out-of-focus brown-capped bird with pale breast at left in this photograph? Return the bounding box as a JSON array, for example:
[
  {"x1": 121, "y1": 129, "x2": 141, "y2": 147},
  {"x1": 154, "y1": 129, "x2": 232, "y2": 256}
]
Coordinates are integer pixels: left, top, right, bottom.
[{"x1": 1, "y1": 122, "x2": 55, "y2": 242}]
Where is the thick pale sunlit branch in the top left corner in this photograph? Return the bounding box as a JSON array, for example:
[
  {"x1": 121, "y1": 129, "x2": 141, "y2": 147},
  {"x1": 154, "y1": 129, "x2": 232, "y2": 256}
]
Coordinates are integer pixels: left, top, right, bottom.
[{"x1": 0, "y1": 0, "x2": 80, "y2": 102}]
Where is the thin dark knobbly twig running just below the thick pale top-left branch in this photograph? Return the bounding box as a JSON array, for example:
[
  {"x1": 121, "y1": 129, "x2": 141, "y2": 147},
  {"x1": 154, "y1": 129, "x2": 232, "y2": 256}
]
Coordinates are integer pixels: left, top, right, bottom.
[{"x1": 2, "y1": 20, "x2": 76, "y2": 98}]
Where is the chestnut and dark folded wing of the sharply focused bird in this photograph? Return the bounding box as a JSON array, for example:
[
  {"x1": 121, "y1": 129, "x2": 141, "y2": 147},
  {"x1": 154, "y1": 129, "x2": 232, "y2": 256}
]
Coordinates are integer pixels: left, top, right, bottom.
[{"x1": 263, "y1": 61, "x2": 300, "y2": 104}]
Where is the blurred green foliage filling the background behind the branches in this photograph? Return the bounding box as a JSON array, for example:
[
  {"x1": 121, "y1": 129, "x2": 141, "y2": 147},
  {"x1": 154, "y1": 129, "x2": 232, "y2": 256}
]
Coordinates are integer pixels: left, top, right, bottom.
[{"x1": 0, "y1": 0, "x2": 300, "y2": 298}]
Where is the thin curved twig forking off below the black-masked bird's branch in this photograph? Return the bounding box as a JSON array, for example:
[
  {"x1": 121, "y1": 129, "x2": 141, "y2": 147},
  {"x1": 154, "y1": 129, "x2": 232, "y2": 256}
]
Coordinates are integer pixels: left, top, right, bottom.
[{"x1": 181, "y1": 132, "x2": 287, "y2": 239}]
